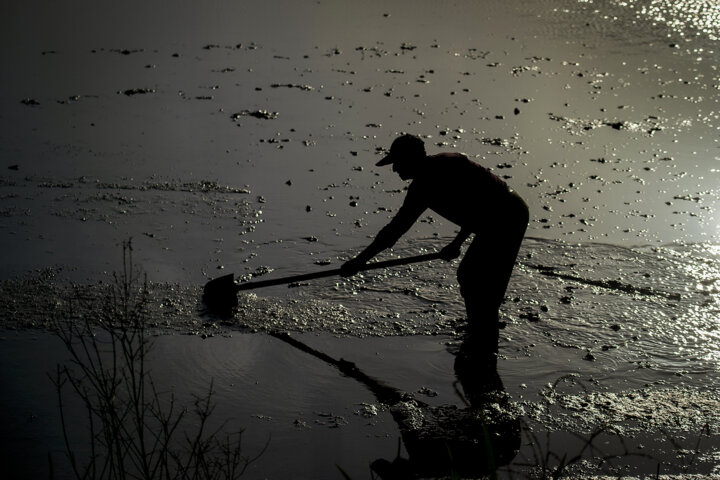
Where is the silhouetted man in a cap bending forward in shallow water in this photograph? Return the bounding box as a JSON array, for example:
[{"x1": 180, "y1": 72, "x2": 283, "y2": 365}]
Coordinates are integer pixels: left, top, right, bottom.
[{"x1": 341, "y1": 135, "x2": 528, "y2": 353}]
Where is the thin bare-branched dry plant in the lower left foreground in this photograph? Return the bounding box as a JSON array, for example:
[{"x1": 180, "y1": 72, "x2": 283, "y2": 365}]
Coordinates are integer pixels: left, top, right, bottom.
[{"x1": 52, "y1": 241, "x2": 267, "y2": 480}]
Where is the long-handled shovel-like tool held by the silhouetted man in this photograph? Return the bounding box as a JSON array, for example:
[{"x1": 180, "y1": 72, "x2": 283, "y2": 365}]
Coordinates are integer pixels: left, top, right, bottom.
[{"x1": 203, "y1": 252, "x2": 440, "y2": 312}]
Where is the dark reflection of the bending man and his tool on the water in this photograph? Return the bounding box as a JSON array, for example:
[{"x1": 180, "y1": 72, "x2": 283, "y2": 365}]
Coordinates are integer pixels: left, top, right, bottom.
[{"x1": 271, "y1": 332, "x2": 521, "y2": 480}]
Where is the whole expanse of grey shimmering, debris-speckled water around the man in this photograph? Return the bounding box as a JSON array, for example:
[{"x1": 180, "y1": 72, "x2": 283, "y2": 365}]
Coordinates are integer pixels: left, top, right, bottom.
[{"x1": 0, "y1": 0, "x2": 720, "y2": 478}]
